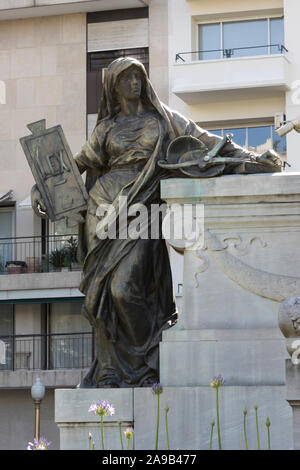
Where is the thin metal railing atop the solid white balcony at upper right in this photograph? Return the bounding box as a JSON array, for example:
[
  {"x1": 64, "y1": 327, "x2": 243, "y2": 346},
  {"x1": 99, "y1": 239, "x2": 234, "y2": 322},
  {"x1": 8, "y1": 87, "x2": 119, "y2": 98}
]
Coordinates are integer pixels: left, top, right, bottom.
[{"x1": 175, "y1": 44, "x2": 288, "y2": 62}]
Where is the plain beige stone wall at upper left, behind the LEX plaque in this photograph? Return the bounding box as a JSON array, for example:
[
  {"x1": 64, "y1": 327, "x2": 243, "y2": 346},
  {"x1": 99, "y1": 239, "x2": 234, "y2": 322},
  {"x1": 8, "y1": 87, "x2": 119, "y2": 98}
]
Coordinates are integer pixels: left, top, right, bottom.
[{"x1": 0, "y1": 14, "x2": 86, "y2": 236}]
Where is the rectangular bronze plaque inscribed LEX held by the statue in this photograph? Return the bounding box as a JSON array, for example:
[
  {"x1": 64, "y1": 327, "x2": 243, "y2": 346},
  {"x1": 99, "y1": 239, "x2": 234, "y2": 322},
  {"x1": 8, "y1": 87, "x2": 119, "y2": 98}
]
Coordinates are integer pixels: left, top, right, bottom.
[{"x1": 20, "y1": 119, "x2": 88, "y2": 221}]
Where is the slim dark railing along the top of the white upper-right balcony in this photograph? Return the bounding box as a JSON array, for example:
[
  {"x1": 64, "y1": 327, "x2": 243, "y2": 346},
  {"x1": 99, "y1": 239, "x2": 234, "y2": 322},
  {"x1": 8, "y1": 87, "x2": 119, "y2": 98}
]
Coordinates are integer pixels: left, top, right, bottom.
[{"x1": 175, "y1": 44, "x2": 288, "y2": 62}]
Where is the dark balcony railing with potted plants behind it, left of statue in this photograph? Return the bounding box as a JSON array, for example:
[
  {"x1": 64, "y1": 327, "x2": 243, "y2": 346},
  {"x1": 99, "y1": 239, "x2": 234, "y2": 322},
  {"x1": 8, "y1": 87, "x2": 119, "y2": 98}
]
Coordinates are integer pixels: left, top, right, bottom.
[{"x1": 0, "y1": 235, "x2": 81, "y2": 274}]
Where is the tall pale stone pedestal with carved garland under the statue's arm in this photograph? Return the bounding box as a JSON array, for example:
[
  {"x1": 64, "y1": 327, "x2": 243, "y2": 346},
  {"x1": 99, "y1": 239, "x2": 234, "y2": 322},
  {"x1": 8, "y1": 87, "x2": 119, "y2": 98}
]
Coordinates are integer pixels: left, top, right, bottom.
[{"x1": 160, "y1": 173, "x2": 300, "y2": 449}]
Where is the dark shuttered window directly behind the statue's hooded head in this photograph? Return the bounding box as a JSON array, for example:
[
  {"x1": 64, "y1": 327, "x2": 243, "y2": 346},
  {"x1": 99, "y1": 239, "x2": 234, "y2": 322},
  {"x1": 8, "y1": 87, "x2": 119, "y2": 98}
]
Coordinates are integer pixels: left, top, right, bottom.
[{"x1": 87, "y1": 47, "x2": 149, "y2": 114}]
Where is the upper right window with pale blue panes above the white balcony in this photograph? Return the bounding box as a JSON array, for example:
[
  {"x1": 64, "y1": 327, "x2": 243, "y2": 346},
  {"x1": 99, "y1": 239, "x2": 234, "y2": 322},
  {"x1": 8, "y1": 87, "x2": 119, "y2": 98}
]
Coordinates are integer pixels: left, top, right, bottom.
[{"x1": 198, "y1": 18, "x2": 284, "y2": 60}]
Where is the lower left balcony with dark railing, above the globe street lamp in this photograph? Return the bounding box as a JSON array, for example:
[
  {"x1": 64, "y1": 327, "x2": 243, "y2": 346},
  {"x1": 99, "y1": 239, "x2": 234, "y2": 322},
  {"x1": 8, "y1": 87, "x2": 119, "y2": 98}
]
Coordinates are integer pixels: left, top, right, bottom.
[{"x1": 0, "y1": 332, "x2": 95, "y2": 388}]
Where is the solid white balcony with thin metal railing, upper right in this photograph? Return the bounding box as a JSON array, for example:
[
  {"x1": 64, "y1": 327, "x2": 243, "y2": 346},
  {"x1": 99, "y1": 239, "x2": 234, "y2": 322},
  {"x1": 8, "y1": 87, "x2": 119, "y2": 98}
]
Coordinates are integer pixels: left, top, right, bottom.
[{"x1": 172, "y1": 44, "x2": 289, "y2": 104}]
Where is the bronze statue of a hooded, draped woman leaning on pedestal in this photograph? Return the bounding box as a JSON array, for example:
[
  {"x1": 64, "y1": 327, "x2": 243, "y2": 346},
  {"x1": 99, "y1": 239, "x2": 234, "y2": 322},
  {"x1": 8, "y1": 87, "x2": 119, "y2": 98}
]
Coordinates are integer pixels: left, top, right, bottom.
[{"x1": 33, "y1": 58, "x2": 279, "y2": 387}]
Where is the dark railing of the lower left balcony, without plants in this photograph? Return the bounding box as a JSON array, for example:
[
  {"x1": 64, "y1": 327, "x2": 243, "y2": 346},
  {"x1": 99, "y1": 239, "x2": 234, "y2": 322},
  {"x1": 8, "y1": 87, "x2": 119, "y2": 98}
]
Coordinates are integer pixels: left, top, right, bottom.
[{"x1": 0, "y1": 333, "x2": 94, "y2": 372}]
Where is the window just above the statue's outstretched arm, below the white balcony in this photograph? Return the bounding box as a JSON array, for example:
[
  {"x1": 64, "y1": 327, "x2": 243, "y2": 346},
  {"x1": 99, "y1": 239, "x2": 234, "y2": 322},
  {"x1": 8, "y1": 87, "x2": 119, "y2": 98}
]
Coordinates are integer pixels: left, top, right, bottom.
[{"x1": 209, "y1": 125, "x2": 286, "y2": 155}]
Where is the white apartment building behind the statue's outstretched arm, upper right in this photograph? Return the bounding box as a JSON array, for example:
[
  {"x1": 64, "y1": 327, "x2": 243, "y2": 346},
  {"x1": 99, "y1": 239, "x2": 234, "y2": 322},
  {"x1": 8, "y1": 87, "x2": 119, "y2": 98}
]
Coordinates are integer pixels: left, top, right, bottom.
[{"x1": 169, "y1": 0, "x2": 300, "y2": 171}]
